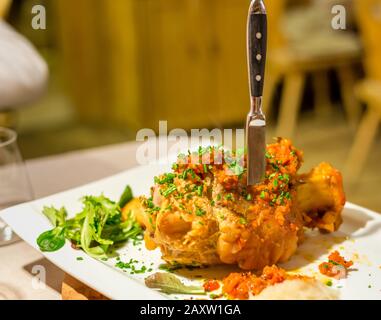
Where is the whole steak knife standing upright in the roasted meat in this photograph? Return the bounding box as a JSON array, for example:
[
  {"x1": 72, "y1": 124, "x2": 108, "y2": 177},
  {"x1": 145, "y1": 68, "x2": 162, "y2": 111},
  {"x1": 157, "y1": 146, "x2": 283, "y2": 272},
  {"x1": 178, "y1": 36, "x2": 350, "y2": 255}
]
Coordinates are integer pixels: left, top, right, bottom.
[{"x1": 246, "y1": 0, "x2": 267, "y2": 185}]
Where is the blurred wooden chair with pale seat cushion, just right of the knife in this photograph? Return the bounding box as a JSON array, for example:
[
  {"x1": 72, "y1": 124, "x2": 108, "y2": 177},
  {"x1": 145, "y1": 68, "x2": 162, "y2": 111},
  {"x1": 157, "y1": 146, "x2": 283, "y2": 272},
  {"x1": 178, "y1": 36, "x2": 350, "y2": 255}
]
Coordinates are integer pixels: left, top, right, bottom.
[{"x1": 264, "y1": 0, "x2": 361, "y2": 137}]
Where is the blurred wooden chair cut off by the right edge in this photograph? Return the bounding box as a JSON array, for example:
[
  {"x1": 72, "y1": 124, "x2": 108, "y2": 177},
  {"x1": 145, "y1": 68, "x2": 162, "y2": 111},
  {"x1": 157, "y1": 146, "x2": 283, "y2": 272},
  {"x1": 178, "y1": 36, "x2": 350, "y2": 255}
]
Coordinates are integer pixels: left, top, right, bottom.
[{"x1": 345, "y1": 0, "x2": 381, "y2": 183}]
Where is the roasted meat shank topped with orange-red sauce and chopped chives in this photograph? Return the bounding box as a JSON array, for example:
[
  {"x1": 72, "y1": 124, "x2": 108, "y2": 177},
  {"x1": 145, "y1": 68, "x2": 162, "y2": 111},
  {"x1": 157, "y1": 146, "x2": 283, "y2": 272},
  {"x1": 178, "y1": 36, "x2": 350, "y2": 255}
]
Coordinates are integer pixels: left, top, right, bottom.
[{"x1": 136, "y1": 139, "x2": 345, "y2": 270}]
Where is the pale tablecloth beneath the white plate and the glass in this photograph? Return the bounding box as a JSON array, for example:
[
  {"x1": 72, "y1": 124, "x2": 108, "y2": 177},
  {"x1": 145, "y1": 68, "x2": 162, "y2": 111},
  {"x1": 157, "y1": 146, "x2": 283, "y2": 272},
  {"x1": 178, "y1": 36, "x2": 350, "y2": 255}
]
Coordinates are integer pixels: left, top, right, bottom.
[{"x1": 0, "y1": 142, "x2": 138, "y2": 299}]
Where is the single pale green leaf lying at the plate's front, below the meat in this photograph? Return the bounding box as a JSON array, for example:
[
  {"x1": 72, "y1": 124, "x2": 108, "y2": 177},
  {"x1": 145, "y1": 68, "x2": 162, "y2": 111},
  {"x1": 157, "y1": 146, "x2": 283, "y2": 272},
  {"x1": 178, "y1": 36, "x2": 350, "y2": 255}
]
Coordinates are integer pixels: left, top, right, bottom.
[{"x1": 145, "y1": 272, "x2": 205, "y2": 295}]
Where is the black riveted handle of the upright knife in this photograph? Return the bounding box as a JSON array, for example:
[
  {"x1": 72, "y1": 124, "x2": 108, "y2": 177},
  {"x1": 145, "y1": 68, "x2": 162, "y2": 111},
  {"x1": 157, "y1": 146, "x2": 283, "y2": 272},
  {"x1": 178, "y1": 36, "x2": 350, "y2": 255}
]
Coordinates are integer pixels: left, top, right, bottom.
[{"x1": 247, "y1": 0, "x2": 267, "y2": 97}]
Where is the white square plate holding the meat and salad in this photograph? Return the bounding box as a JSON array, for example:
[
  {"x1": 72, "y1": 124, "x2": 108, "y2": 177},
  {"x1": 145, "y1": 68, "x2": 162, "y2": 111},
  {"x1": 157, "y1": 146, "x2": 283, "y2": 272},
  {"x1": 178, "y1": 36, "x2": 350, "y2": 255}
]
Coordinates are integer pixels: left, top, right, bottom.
[{"x1": 0, "y1": 164, "x2": 381, "y2": 300}]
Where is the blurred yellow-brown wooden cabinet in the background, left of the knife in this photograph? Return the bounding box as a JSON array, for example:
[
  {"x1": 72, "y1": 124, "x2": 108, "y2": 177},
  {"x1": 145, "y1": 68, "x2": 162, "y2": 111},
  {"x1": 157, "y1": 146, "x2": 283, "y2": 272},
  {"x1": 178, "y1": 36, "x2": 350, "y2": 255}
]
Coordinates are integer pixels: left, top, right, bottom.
[{"x1": 55, "y1": 0, "x2": 248, "y2": 129}]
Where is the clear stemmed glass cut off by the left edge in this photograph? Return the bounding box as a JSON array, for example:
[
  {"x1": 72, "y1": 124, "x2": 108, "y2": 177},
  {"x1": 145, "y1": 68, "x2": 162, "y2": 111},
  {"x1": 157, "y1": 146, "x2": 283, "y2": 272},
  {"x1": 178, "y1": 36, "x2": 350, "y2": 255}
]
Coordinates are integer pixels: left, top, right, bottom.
[{"x1": 0, "y1": 127, "x2": 33, "y2": 246}]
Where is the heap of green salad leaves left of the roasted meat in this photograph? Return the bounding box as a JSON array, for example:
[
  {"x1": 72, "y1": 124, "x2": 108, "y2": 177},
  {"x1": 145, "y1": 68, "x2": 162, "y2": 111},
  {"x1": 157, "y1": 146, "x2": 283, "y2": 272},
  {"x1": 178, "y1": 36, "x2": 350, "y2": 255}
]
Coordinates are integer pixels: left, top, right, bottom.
[{"x1": 37, "y1": 186, "x2": 143, "y2": 259}]
